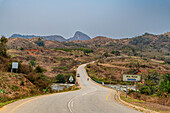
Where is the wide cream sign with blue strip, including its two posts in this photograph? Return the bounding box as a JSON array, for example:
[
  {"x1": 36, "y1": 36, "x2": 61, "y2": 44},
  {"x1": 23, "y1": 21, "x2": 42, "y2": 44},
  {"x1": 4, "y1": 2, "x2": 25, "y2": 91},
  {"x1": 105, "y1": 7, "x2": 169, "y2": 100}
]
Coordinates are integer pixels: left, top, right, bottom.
[{"x1": 123, "y1": 74, "x2": 142, "y2": 98}]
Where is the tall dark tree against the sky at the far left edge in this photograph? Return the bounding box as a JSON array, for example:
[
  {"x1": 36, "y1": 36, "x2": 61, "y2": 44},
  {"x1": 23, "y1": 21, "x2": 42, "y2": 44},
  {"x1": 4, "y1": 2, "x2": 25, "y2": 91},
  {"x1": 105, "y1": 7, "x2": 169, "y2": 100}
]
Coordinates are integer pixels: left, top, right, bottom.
[{"x1": 0, "y1": 36, "x2": 8, "y2": 57}]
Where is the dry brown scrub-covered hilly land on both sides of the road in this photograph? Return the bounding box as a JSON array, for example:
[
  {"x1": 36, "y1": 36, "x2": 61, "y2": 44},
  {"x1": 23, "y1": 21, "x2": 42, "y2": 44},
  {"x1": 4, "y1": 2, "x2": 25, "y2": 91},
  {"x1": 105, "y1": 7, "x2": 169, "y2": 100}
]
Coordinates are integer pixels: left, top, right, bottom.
[{"x1": 0, "y1": 33, "x2": 170, "y2": 108}]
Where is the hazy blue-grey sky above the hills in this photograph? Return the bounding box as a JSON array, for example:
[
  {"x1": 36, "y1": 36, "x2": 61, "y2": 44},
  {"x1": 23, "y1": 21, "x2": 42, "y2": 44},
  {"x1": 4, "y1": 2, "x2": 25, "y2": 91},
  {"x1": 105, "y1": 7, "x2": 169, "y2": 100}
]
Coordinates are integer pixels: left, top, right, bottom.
[{"x1": 0, "y1": 0, "x2": 170, "y2": 38}]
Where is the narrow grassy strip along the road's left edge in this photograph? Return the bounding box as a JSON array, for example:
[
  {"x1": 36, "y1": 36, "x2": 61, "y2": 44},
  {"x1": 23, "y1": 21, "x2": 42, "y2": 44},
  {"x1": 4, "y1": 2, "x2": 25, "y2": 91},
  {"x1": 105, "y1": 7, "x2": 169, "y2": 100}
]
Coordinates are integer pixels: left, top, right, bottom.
[{"x1": 0, "y1": 87, "x2": 80, "y2": 110}]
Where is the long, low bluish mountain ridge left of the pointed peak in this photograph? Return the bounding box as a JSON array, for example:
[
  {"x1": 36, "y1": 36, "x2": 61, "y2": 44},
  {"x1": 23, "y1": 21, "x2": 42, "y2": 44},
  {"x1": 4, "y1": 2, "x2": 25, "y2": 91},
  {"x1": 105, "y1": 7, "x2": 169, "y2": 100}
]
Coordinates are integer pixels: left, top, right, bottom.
[{"x1": 10, "y1": 34, "x2": 66, "y2": 41}]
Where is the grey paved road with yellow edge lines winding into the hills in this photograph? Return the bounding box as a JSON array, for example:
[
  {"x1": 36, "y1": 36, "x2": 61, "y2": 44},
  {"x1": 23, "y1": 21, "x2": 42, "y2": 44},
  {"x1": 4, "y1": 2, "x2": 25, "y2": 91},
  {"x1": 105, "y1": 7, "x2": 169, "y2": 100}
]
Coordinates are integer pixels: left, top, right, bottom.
[{"x1": 0, "y1": 64, "x2": 139, "y2": 113}]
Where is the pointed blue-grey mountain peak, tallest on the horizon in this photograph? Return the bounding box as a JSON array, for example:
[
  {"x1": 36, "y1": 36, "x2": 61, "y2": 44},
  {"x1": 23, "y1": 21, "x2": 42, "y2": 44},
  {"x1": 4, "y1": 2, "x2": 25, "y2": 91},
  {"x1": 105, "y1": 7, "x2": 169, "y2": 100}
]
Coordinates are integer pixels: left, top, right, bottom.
[{"x1": 68, "y1": 31, "x2": 91, "y2": 41}]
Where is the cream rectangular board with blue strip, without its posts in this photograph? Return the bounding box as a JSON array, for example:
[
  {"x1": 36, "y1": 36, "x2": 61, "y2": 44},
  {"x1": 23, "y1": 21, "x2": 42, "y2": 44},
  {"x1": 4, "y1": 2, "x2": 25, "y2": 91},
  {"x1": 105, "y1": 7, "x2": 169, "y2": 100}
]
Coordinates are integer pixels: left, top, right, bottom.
[{"x1": 123, "y1": 74, "x2": 142, "y2": 82}]
